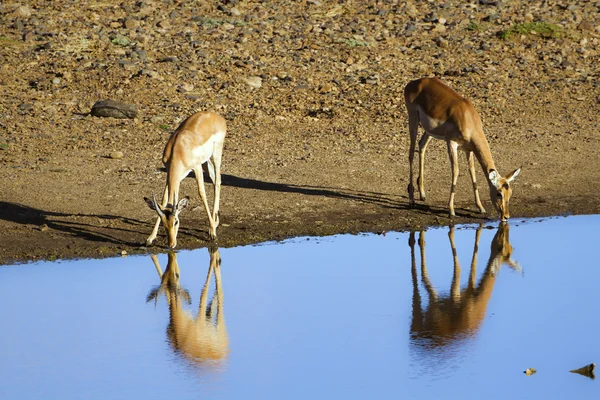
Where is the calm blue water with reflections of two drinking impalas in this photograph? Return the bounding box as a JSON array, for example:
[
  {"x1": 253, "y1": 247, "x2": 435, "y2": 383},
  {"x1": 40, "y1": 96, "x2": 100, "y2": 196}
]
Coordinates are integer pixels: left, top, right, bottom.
[{"x1": 0, "y1": 216, "x2": 600, "y2": 399}]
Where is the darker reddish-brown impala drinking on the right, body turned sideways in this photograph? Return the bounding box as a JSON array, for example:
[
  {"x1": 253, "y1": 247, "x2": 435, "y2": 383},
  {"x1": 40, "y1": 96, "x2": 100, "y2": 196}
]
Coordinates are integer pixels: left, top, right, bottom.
[{"x1": 404, "y1": 78, "x2": 521, "y2": 221}]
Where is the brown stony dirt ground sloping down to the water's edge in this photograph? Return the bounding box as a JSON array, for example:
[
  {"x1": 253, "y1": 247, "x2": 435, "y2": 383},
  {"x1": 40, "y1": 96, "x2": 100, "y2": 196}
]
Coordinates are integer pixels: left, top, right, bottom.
[{"x1": 0, "y1": 0, "x2": 600, "y2": 264}]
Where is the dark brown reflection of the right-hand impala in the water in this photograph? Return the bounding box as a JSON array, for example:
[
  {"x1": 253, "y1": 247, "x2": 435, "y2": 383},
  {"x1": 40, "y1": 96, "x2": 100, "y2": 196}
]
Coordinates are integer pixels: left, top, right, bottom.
[{"x1": 409, "y1": 222, "x2": 520, "y2": 350}]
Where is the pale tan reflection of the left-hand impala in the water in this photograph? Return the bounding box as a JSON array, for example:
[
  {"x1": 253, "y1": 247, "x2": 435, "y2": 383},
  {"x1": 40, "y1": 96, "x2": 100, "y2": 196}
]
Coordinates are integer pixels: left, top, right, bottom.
[{"x1": 147, "y1": 247, "x2": 229, "y2": 367}]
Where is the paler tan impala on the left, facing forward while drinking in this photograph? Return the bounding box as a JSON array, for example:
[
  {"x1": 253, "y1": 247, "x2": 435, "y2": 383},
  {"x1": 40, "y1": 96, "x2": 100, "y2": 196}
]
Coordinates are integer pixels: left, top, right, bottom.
[{"x1": 144, "y1": 112, "x2": 226, "y2": 248}]
